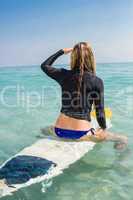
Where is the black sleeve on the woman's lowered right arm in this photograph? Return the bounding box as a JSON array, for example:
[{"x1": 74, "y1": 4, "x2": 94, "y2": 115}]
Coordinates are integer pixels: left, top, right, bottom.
[{"x1": 94, "y1": 79, "x2": 106, "y2": 129}]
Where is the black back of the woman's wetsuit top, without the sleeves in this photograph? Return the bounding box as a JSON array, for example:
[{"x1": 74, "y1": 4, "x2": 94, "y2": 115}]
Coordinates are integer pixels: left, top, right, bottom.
[{"x1": 60, "y1": 70, "x2": 102, "y2": 121}]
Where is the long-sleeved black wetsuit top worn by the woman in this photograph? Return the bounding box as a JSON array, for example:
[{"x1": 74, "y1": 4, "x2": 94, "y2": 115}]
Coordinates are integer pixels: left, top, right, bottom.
[{"x1": 41, "y1": 49, "x2": 106, "y2": 129}]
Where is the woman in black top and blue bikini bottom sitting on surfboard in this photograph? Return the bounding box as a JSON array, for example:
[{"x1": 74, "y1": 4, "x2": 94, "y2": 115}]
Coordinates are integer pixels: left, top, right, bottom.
[{"x1": 41, "y1": 42, "x2": 127, "y2": 147}]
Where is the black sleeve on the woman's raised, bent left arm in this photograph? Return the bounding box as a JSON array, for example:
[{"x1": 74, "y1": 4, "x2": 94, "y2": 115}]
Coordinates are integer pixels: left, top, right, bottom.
[{"x1": 41, "y1": 49, "x2": 65, "y2": 83}]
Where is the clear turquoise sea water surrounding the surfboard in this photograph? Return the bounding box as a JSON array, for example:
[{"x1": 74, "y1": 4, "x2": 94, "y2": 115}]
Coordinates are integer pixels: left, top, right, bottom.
[{"x1": 0, "y1": 63, "x2": 133, "y2": 200}]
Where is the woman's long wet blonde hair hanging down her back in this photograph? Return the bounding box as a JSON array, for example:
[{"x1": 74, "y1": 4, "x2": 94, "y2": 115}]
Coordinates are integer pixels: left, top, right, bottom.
[{"x1": 70, "y1": 42, "x2": 96, "y2": 93}]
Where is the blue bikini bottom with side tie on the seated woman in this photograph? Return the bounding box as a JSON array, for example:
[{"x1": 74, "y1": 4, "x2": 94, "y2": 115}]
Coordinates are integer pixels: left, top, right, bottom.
[{"x1": 54, "y1": 127, "x2": 95, "y2": 139}]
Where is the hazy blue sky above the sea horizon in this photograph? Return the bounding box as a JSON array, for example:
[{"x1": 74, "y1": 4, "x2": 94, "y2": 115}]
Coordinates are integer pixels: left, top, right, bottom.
[{"x1": 0, "y1": 0, "x2": 133, "y2": 65}]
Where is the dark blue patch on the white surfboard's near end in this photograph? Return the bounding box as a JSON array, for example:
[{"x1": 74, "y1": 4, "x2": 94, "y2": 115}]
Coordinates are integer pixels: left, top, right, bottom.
[{"x1": 0, "y1": 155, "x2": 56, "y2": 186}]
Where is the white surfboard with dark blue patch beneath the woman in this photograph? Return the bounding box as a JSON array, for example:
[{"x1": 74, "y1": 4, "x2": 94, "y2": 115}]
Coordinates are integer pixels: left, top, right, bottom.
[{"x1": 0, "y1": 110, "x2": 111, "y2": 197}]
